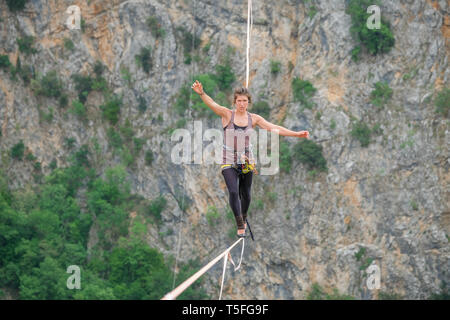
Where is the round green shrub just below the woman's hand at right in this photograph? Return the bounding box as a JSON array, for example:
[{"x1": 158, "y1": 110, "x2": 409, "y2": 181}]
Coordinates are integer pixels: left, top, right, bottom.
[{"x1": 293, "y1": 139, "x2": 328, "y2": 171}]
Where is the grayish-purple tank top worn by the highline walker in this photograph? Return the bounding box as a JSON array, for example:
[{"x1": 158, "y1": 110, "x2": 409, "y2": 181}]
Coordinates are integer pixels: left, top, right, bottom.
[{"x1": 222, "y1": 110, "x2": 255, "y2": 165}]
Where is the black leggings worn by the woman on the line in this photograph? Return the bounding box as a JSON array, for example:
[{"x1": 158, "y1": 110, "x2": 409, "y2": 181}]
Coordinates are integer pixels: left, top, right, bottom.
[{"x1": 222, "y1": 168, "x2": 253, "y2": 229}]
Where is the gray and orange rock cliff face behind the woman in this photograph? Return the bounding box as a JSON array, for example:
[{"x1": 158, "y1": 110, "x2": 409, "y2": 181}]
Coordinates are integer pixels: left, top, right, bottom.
[{"x1": 0, "y1": 0, "x2": 450, "y2": 299}]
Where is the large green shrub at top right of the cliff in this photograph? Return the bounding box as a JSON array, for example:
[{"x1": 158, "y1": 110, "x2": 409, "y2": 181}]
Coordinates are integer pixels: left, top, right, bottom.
[{"x1": 346, "y1": 0, "x2": 395, "y2": 61}]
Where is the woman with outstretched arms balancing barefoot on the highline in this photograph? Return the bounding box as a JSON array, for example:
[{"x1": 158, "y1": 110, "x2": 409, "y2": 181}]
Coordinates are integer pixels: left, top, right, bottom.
[{"x1": 192, "y1": 80, "x2": 309, "y2": 237}]
